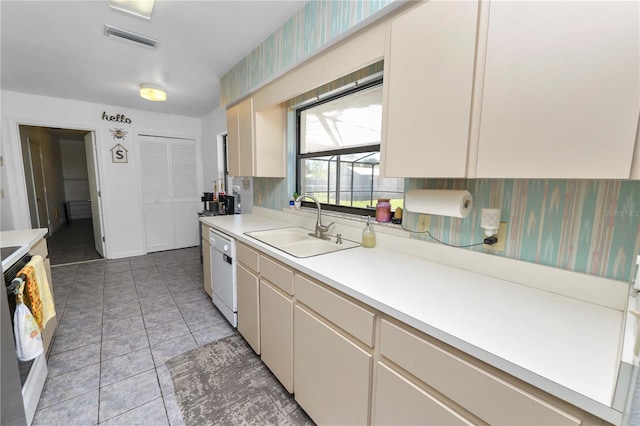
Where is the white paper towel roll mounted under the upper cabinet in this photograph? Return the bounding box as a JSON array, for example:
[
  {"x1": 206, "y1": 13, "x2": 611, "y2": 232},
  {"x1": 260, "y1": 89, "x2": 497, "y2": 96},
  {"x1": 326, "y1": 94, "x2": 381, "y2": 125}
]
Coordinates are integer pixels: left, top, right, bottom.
[{"x1": 404, "y1": 189, "x2": 473, "y2": 217}]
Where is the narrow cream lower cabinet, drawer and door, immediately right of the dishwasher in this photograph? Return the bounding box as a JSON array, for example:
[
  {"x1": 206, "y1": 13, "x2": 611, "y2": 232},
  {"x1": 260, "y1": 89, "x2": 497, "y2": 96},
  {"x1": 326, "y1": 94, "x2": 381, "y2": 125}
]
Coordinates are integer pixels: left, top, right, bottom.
[{"x1": 236, "y1": 243, "x2": 260, "y2": 355}]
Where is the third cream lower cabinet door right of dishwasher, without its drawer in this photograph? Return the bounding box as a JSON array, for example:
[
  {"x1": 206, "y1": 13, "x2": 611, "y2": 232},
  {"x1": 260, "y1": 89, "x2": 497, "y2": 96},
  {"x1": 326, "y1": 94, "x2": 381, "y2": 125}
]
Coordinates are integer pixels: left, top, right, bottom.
[{"x1": 293, "y1": 305, "x2": 373, "y2": 425}]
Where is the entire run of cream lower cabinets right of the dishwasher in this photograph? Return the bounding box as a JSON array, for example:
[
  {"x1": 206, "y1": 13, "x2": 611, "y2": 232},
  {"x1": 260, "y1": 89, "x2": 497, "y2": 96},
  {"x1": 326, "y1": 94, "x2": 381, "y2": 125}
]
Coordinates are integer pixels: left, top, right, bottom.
[{"x1": 232, "y1": 243, "x2": 604, "y2": 426}]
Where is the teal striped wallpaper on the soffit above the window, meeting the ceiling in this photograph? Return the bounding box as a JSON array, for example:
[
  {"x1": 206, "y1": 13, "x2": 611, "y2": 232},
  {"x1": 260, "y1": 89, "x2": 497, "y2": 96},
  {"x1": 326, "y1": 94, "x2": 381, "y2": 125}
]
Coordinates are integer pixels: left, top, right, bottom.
[{"x1": 220, "y1": 0, "x2": 393, "y2": 106}]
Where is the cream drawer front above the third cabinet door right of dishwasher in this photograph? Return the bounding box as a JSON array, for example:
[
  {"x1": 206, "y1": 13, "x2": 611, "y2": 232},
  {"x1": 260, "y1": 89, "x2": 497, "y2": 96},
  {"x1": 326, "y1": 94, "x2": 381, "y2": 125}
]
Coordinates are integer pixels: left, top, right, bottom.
[{"x1": 295, "y1": 275, "x2": 376, "y2": 347}]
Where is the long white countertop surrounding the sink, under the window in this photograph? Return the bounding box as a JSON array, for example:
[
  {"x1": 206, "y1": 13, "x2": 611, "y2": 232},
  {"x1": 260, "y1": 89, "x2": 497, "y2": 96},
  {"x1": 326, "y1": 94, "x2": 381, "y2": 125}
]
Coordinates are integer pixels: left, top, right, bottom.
[{"x1": 201, "y1": 214, "x2": 624, "y2": 423}]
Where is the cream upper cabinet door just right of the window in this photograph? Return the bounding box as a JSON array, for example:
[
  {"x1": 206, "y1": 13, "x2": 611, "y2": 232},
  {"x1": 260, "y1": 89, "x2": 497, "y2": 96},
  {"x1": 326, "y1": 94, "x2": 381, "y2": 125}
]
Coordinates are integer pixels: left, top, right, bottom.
[{"x1": 381, "y1": 1, "x2": 478, "y2": 177}]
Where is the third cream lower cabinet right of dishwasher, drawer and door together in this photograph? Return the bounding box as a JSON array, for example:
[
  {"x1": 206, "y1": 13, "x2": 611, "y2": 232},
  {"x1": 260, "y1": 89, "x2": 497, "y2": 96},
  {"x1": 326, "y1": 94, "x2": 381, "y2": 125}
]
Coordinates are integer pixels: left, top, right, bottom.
[{"x1": 293, "y1": 274, "x2": 375, "y2": 425}]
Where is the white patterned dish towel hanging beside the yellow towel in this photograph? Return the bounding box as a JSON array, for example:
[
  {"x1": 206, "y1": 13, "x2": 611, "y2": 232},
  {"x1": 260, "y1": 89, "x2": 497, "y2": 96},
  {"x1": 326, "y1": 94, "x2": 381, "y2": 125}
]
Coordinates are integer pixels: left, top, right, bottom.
[{"x1": 13, "y1": 278, "x2": 44, "y2": 361}]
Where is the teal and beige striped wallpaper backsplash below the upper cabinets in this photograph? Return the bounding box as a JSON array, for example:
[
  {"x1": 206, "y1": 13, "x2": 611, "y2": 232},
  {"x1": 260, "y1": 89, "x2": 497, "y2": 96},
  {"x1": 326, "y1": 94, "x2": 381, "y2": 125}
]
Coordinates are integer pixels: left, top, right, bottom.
[{"x1": 254, "y1": 173, "x2": 640, "y2": 281}]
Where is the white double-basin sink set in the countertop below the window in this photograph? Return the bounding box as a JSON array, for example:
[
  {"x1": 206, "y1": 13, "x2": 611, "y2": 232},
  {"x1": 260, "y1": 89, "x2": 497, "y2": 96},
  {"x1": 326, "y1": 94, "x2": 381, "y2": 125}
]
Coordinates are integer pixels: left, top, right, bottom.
[{"x1": 245, "y1": 228, "x2": 360, "y2": 257}]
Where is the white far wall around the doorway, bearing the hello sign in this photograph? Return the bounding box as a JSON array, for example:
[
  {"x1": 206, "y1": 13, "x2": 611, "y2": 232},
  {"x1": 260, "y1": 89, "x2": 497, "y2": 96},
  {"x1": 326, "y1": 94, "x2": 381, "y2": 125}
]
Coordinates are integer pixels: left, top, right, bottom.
[{"x1": 0, "y1": 91, "x2": 202, "y2": 258}]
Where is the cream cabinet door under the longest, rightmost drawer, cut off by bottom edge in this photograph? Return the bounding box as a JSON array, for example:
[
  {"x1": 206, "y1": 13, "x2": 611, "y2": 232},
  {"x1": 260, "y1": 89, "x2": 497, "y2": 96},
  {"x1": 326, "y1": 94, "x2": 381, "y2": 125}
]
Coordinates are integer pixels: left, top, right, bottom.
[{"x1": 374, "y1": 362, "x2": 473, "y2": 425}]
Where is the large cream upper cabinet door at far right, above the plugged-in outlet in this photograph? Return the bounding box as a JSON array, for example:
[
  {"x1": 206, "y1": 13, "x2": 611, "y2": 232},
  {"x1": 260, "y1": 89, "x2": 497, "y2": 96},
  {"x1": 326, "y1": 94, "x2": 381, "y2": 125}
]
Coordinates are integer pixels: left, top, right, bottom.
[{"x1": 476, "y1": 1, "x2": 640, "y2": 178}]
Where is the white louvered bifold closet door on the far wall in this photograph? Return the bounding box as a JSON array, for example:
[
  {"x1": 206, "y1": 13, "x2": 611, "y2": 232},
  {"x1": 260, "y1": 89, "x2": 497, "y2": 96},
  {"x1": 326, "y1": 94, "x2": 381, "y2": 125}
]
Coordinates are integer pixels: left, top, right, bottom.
[{"x1": 140, "y1": 136, "x2": 199, "y2": 252}]
